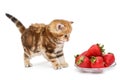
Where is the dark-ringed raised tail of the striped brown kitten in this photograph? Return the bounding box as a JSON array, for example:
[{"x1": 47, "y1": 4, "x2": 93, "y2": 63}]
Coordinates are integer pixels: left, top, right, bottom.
[{"x1": 5, "y1": 13, "x2": 25, "y2": 33}]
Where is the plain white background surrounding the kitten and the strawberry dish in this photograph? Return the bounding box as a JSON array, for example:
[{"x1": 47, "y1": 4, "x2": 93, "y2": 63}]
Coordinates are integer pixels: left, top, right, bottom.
[{"x1": 0, "y1": 0, "x2": 120, "y2": 80}]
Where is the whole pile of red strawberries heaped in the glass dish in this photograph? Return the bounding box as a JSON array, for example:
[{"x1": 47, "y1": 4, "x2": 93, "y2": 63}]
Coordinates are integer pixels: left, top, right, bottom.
[{"x1": 75, "y1": 44, "x2": 115, "y2": 68}]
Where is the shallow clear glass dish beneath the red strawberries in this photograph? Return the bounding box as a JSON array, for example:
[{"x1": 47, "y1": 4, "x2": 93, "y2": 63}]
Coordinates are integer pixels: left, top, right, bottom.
[{"x1": 75, "y1": 62, "x2": 116, "y2": 73}]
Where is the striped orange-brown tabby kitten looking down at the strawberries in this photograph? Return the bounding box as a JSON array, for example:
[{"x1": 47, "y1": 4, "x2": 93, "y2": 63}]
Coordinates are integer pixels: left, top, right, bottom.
[{"x1": 6, "y1": 13, "x2": 73, "y2": 69}]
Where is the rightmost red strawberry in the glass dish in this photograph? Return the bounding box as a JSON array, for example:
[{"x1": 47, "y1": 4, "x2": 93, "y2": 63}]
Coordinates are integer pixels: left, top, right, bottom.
[{"x1": 103, "y1": 53, "x2": 115, "y2": 67}]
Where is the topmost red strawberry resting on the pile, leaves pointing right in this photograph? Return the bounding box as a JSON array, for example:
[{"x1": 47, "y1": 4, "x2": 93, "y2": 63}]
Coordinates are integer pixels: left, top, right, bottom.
[{"x1": 86, "y1": 44, "x2": 104, "y2": 57}]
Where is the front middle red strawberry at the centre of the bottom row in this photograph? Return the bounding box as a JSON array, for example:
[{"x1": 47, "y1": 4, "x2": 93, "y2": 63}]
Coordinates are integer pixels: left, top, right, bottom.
[{"x1": 91, "y1": 56, "x2": 104, "y2": 68}]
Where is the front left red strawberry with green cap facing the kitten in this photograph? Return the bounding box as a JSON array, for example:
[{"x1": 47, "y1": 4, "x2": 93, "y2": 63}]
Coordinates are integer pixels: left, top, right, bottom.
[{"x1": 75, "y1": 56, "x2": 91, "y2": 68}]
